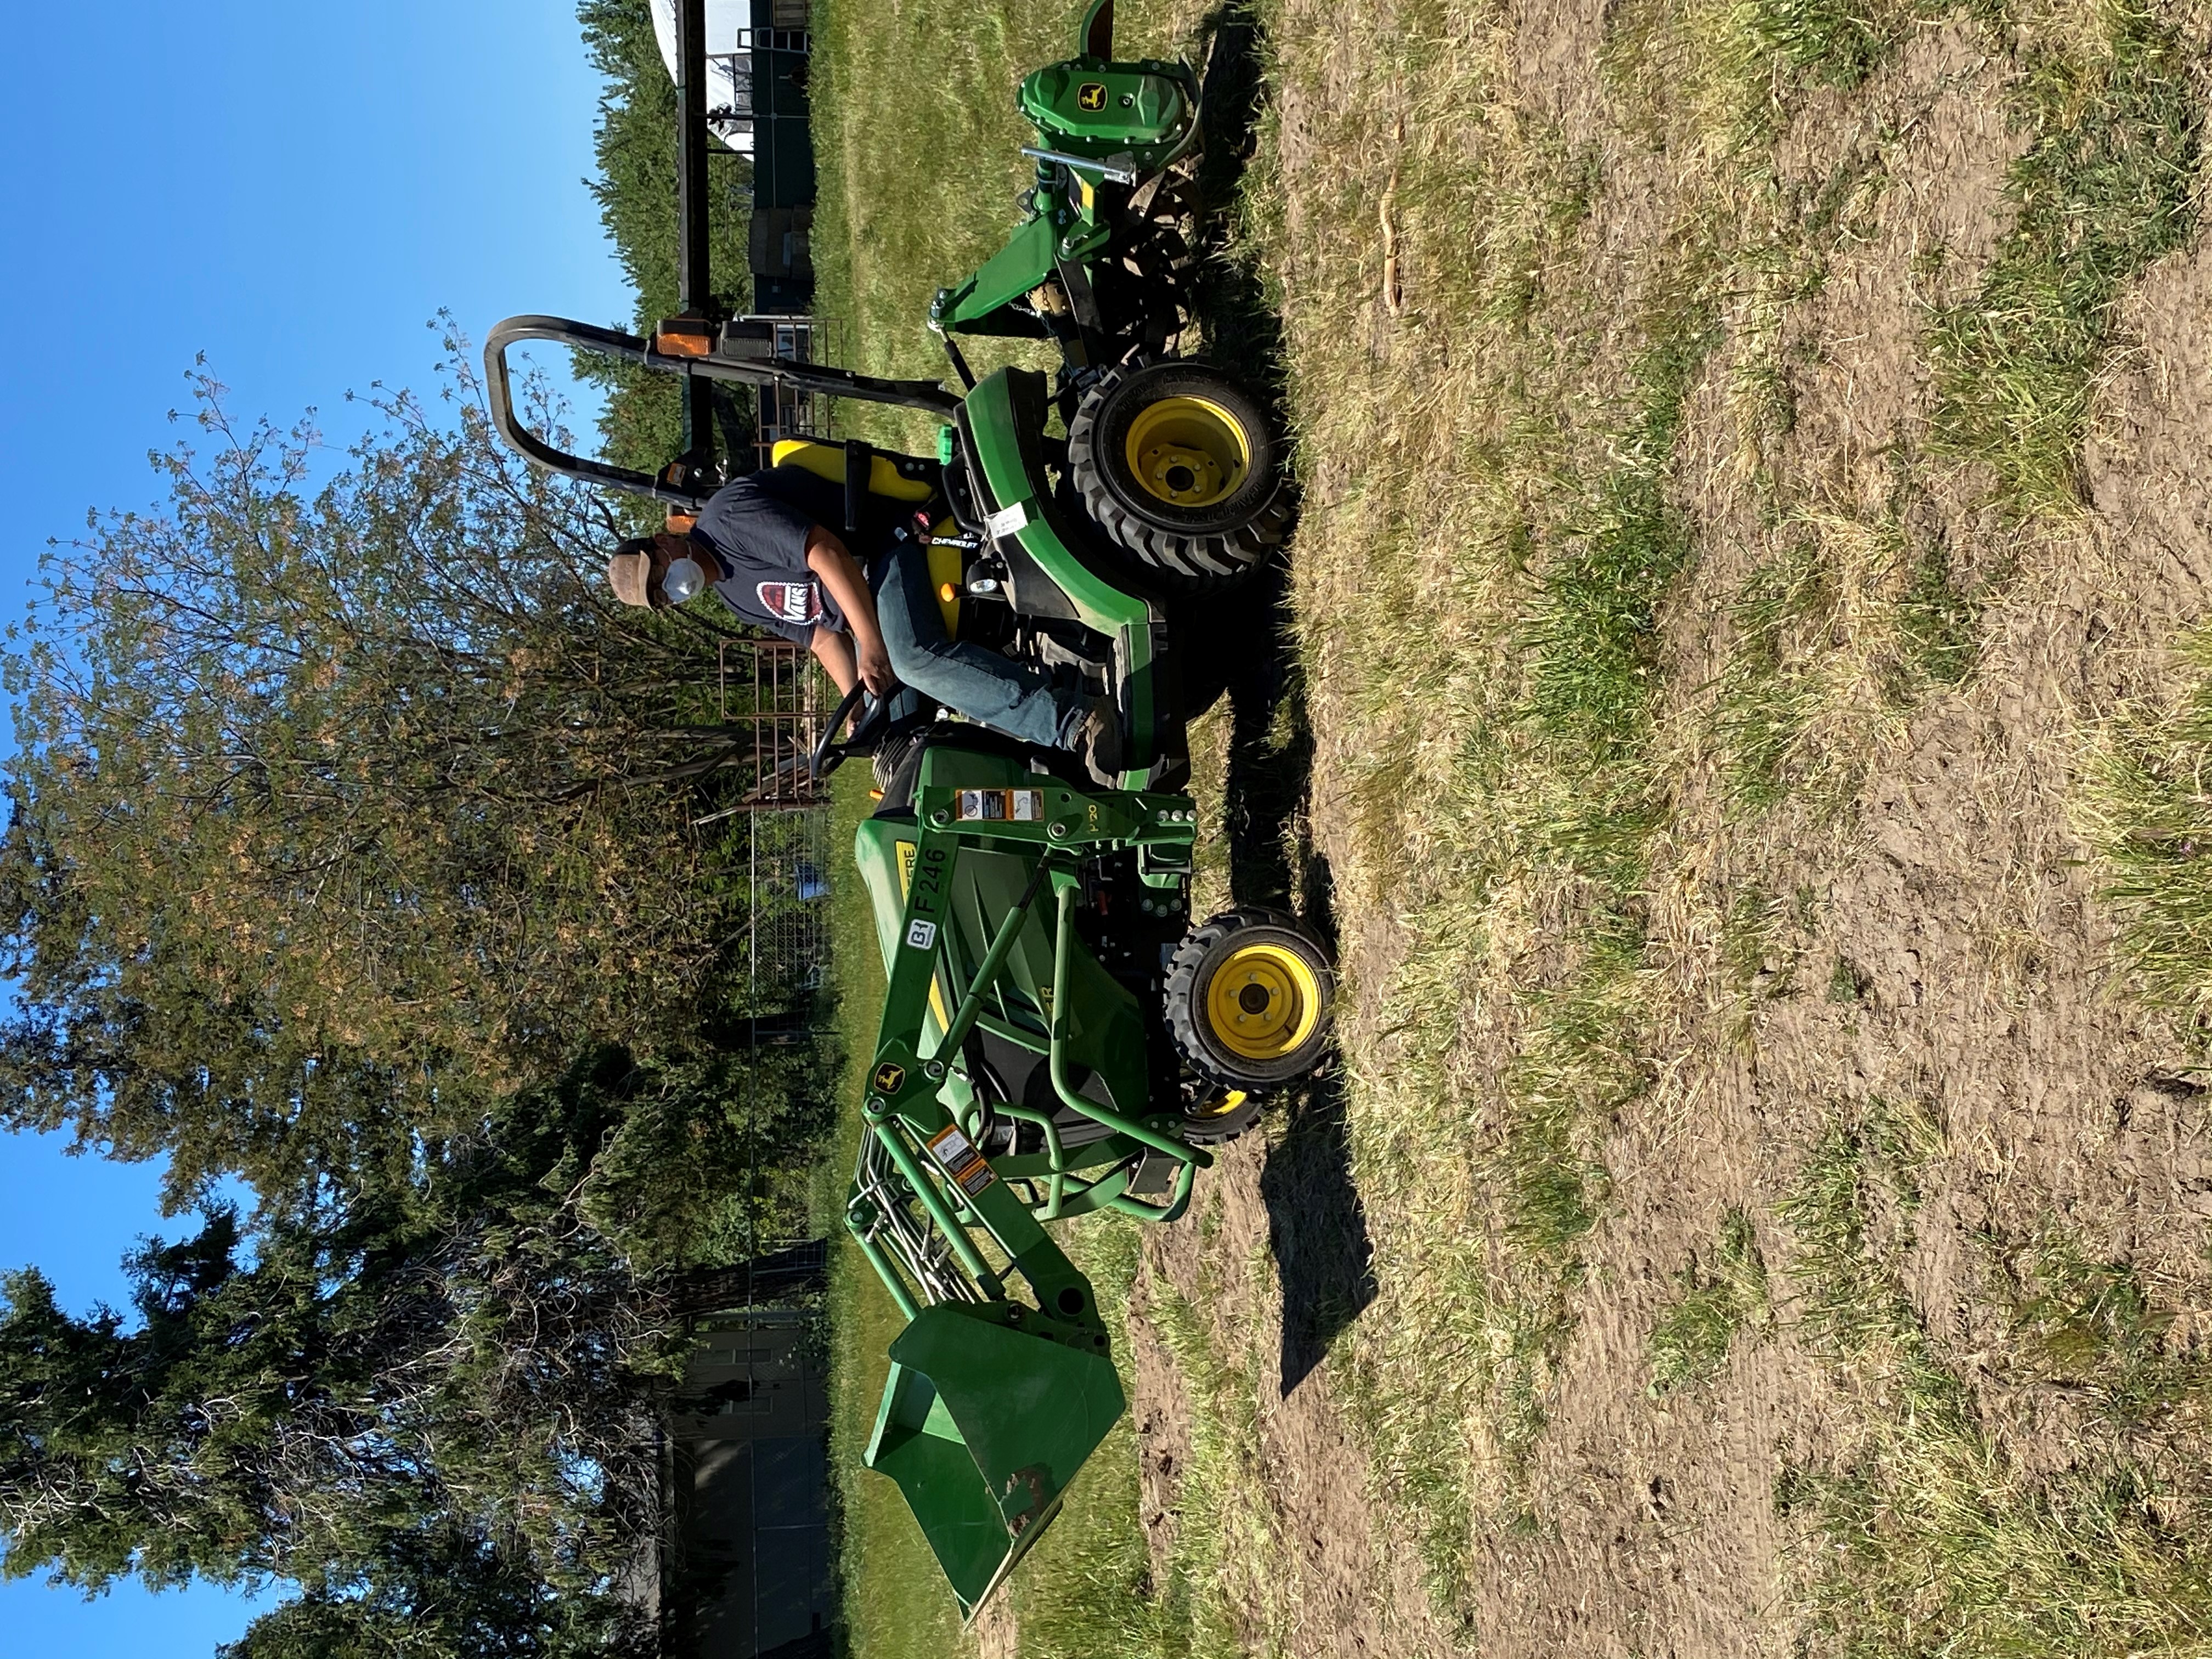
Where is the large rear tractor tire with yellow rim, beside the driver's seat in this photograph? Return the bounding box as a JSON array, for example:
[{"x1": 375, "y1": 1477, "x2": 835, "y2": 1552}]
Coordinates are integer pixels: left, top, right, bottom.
[{"x1": 1068, "y1": 358, "x2": 1290, "y2": 593}]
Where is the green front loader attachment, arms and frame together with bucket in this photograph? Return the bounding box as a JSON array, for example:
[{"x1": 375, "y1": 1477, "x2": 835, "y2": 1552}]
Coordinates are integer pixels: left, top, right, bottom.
[{"x1": 847, "y1": 754, "x2": 1212, "y2": 1617}]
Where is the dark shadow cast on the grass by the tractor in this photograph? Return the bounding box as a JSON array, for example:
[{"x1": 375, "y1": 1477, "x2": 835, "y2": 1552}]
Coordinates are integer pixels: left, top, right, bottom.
[{"x1": 1197, "y1": 7, "x2": 1376, "y2": 1398}]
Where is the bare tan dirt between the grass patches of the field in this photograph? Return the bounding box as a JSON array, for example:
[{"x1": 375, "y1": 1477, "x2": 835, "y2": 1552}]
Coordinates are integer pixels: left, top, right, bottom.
[{"x1": 1130, "y1": 0, "x2": 2212, "y2": 1657}]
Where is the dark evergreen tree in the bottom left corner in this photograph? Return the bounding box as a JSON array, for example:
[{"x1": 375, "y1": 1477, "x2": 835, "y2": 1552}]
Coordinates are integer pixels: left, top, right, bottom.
[{"x1": 0, "y1": 1051, "x2": 699, "y2": 1659}]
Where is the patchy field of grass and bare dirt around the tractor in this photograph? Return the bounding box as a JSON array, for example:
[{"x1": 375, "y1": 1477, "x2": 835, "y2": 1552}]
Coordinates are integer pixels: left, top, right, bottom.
[{"x1": 816, "y1": 0, "x2": 2212, "y2": 1655}]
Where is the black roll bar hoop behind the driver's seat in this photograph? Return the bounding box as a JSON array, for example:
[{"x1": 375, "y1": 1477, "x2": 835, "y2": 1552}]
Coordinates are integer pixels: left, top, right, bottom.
[{"x1": 484, "y1": 317, "x2": 960, "y2": 513}]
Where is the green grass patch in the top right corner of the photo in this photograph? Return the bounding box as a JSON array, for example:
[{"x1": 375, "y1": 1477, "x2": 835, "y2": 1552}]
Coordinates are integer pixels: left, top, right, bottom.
[{"x1": 1929, "y1": 0, "x2": 2203, "y2": 515}]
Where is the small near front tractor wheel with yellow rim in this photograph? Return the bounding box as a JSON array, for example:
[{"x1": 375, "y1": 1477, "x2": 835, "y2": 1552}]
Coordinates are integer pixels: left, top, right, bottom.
[{"x1": 1166, "y1": 909, "x2": 1336, "y2": 1093}]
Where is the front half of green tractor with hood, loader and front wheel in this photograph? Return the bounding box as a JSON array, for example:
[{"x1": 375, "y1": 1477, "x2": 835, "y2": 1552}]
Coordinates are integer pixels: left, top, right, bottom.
[{"x1": 822, "y1": 743, "x2": 1331, "y2": 1612}]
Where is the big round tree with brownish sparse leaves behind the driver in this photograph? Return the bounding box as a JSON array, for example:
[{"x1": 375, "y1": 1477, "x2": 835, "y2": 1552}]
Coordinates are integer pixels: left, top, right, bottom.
[{"x1": 0, "y1": 354, "x2": 814, "y2": 1201}]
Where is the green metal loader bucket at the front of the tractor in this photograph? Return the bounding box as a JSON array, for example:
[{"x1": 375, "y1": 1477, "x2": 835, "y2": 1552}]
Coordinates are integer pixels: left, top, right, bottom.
[{"x1": 865, "y1": 1303, "x2": 1121, "y2": 1615}]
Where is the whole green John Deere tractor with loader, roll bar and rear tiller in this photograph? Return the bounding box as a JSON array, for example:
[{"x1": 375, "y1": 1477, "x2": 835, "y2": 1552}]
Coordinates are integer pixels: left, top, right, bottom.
[{"x1": 484, "y1": 0, "x2": 1331, "y2": 1612}]
